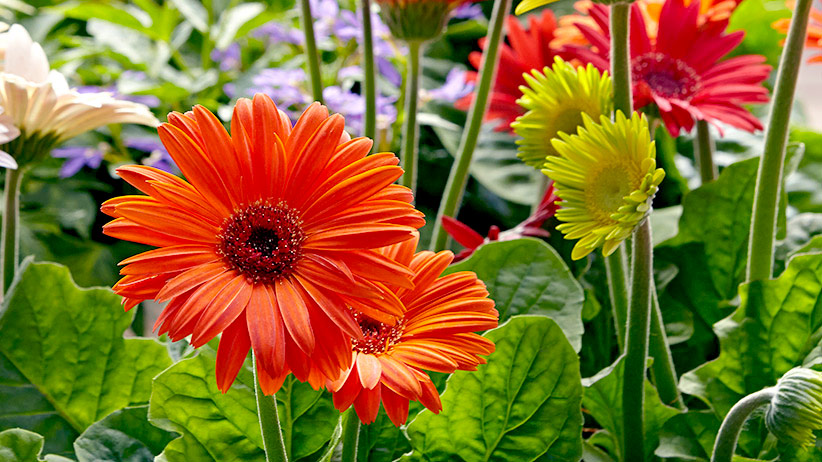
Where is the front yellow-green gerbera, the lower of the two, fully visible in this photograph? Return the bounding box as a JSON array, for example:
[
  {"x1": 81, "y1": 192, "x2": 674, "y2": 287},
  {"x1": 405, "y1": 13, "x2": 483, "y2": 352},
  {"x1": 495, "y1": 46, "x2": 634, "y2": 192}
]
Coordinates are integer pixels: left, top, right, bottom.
[{"x1": 542, "y1": 111, "x2": 665, "y2": 260}]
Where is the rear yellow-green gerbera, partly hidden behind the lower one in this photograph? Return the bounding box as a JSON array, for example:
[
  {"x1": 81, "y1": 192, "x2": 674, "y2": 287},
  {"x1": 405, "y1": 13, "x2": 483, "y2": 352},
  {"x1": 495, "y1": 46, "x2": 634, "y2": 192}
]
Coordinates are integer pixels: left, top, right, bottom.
[{"x1": 511, "y1": 57, "x2": 613, "y2": 168}]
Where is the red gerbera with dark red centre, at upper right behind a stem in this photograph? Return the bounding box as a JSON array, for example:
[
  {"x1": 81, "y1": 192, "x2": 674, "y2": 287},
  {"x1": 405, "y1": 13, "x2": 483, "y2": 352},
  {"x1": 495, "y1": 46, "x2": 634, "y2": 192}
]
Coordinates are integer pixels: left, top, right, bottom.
[{"x1": 568, "y1": 0, "x2": 771, "y2": 136}]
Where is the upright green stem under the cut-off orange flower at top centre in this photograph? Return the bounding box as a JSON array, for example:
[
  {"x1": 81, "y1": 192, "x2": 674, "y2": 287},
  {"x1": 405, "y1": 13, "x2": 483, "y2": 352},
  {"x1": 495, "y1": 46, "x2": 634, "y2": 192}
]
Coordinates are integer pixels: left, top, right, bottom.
[{"x1": 400, "y1": 41, "x2": 422, "y2": 191}]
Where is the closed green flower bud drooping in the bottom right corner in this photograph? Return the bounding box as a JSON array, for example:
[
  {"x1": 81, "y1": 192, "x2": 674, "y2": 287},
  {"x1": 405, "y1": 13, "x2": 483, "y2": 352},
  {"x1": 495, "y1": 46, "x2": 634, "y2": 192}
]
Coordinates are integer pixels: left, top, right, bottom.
[{"x1": 765, "y1": 367, "x2": 822, "y2": 447}]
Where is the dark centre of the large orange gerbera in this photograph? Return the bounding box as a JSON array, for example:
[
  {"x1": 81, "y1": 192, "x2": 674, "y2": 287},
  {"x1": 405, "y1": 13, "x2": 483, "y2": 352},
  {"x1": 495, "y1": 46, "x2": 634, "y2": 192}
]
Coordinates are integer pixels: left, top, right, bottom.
[{"x1": 217, "y1": 201, "x2": 305, "y2": 283}]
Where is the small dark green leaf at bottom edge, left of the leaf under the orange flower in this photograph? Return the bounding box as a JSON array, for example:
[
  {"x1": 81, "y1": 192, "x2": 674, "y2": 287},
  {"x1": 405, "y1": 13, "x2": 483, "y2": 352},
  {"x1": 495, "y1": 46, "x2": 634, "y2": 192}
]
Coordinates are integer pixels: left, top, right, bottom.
[{"x1": 74, "y1": 406, "x2": 175, "y2": 462}]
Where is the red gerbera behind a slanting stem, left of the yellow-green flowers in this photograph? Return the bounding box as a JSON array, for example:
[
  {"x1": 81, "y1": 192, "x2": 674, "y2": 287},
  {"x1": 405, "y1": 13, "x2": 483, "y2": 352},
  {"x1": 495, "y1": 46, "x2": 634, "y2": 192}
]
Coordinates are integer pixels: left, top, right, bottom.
[{"x1": 455, "y1": 10, "x2": 568, "y2": 132}]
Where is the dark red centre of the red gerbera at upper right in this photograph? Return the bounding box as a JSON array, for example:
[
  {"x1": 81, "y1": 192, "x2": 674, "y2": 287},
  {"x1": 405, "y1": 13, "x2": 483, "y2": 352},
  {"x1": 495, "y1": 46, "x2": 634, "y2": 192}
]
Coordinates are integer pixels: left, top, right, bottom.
[{"x1": 631, "y1": 52, "x2": 700, "y2": 100}]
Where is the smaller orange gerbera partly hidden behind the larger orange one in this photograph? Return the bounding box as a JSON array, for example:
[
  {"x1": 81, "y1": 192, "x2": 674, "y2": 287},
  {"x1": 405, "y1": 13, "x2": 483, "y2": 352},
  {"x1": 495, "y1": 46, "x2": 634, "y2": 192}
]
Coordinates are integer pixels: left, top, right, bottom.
[{"x1": 329, "y1": 233, "x2": 499, "y2": 426}]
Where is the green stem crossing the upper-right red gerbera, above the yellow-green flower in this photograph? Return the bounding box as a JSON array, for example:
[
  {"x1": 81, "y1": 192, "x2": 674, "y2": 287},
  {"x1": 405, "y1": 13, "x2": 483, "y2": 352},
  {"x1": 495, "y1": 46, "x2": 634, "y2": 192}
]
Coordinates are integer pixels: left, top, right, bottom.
[{"x1": 611, "y1": 3, "x2": 634, "y2": 117}]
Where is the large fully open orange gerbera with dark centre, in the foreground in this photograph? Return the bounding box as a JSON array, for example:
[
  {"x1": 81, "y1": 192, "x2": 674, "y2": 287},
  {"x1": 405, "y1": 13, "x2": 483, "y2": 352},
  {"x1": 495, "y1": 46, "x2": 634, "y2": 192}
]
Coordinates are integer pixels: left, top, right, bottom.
[{"x1": 102, "y1": 94, "x2": 424, "y2": 394}]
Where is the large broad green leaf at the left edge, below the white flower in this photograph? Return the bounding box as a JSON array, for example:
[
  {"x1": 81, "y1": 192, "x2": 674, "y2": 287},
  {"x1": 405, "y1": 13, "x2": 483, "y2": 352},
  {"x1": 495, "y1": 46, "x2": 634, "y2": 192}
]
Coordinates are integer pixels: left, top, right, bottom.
[{"x1": 0, "y1": 263, "x2": 171, "y2": 453}]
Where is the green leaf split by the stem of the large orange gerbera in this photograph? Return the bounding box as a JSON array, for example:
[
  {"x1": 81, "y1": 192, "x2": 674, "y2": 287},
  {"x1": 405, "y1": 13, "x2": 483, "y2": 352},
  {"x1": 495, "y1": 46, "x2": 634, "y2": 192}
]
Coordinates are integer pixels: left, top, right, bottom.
[{"x1": 149, "y1": 347, "x2": 340, "y2": 462}]
